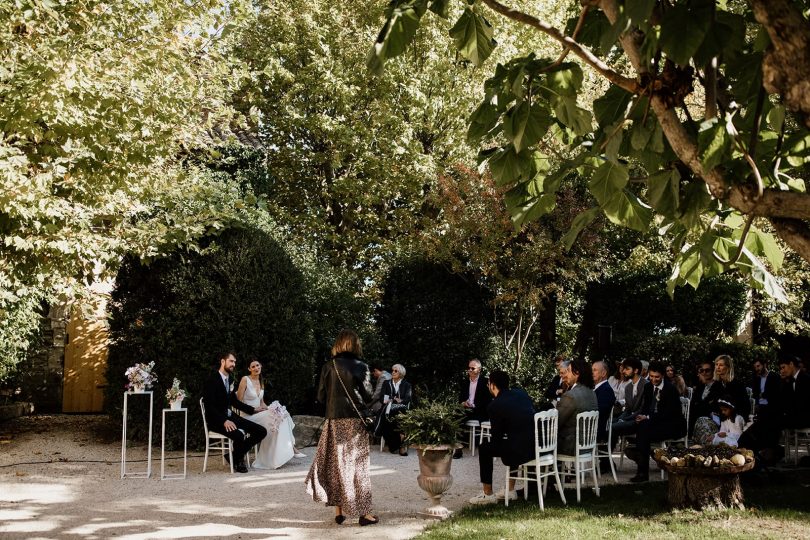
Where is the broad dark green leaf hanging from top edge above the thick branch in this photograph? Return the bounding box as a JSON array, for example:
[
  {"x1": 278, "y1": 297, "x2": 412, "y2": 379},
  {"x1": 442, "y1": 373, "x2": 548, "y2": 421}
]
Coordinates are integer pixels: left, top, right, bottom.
[{"x1": 658, "y1": 0, "x2": 713, "y2": 66}]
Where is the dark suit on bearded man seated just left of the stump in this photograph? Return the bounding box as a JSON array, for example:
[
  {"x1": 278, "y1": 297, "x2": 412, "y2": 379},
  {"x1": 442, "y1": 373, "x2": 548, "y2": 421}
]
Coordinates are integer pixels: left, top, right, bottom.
[{"x1": 636, "y1": 381, "x2": 686, "y2": 476}]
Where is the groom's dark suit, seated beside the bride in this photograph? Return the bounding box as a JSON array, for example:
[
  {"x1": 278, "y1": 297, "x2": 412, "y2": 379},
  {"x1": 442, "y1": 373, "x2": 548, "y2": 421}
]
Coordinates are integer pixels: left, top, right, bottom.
[{"x1": 202, "y1": 371, "x2": 267, "y2": 464}]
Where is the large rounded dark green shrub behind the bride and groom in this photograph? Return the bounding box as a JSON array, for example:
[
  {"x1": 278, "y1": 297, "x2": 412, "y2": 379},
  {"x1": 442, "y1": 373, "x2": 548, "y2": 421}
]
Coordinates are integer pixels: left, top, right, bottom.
[{"x1": 106, "y1": 229, "x2": 315, "y2": 448}]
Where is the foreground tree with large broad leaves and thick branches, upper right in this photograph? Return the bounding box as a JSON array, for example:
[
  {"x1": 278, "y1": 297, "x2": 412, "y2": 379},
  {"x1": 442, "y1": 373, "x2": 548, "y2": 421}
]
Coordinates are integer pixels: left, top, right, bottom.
[{"x1": 368, "y1": 0, "x2": 810, "y2": 297}]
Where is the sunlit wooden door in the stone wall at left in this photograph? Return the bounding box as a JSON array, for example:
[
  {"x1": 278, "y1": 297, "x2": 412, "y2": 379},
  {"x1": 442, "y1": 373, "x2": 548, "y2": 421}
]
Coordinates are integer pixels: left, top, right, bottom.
[{"x1": 62, "y1": 309, "x2": 108, "y2": 413}]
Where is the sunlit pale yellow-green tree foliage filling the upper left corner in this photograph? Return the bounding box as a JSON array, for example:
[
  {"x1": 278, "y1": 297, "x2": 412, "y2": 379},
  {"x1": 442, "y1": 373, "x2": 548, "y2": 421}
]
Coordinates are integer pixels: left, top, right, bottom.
[{"x1": 0, "y1": 0, "x2": 256, "y2": 376}]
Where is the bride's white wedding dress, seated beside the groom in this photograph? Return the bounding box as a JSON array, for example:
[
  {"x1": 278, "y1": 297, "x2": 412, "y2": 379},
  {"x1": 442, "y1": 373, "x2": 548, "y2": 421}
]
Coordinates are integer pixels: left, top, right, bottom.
[{"x1": 242, "y1": 379, "x2": 295, "y2": 469}]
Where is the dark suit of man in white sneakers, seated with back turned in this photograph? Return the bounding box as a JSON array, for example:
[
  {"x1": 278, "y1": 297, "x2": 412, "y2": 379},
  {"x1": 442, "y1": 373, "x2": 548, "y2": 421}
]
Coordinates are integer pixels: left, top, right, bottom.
[{"x1": 478, "y1": 388, "x2": 534, "y2": 484}]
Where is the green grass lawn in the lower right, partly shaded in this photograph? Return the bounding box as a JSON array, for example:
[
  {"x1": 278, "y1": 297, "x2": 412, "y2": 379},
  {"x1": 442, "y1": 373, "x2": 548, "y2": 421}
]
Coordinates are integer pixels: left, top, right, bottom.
[{"x1": 418, "y1": 470, "x2": 810, "y2": 540}]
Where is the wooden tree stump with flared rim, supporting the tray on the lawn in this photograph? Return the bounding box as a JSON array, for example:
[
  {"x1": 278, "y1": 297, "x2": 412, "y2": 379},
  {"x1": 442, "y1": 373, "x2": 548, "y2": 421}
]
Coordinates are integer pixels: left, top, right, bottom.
[{"x1": 663, "y1": 463, "x2": 754, "y2": 510}]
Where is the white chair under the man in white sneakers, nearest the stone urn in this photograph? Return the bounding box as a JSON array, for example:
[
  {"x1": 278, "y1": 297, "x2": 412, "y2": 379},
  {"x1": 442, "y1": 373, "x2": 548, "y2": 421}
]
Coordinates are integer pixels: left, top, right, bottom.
[{"x1": 504, "y1": 409, "x2": 568, "y2": 510}]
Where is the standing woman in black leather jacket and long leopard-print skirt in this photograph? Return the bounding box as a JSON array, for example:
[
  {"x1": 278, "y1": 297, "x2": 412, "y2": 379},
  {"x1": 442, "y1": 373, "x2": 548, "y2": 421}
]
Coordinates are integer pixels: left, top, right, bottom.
[{"x1": 305, "y1": 330, "x2": 379, "y2": 525}]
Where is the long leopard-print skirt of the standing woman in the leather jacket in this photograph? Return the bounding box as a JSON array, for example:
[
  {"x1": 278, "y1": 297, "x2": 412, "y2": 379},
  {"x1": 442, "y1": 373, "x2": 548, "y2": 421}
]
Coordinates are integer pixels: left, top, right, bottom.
[{"x1": 306, "y1": 418, "x2": 371, "y2": 516}]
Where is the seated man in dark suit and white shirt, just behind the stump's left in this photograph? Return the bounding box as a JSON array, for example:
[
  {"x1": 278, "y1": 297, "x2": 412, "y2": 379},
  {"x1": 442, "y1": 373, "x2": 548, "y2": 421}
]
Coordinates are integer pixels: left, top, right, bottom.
[{"x1": 628, "y1": 362, "x2": 686, "y2": 482}]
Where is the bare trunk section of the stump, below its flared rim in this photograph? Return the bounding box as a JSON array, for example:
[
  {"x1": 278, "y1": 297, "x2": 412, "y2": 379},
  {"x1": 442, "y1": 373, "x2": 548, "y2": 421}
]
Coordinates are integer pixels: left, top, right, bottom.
[{"x1": 669, "y1": 474, "x2": 745, "y2": 510}]
